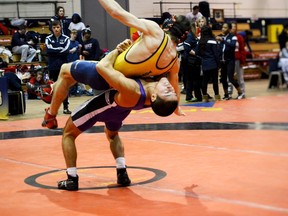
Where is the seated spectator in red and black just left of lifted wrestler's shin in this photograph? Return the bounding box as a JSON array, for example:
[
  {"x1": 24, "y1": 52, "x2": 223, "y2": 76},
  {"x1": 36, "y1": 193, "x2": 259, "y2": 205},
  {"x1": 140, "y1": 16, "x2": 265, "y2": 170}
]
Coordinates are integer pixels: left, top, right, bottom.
[{"x1": 26, "y1": 71, "x2": 53, "y2": 102}]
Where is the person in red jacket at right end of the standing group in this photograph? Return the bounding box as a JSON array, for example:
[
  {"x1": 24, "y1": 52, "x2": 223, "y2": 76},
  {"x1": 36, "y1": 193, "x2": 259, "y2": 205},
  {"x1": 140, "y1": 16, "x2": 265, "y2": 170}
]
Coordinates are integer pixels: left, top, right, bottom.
[{"x1": 231, "y1": 22, "x2": 246, "y2": 94}]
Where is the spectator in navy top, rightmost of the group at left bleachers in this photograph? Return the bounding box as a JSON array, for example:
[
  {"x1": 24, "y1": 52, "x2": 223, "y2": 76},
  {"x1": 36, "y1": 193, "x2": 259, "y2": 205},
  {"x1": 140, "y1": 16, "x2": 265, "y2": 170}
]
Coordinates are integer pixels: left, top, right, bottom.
[{"x1": 81, "y1": 27, "x2": 101, "y2": 61}]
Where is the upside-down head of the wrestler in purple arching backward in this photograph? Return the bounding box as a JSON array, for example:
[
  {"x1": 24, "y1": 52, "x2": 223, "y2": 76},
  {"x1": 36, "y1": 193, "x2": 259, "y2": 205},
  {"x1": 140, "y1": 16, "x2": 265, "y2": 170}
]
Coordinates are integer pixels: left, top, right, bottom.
[{"x1": 151, "y1": 77, "x2": 178, "y2": 117}]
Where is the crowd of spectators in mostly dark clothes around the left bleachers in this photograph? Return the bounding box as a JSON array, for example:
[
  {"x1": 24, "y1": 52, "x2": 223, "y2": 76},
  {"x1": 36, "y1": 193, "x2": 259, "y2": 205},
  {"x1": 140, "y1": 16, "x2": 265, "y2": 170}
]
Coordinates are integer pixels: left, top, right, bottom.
[{"x1": 0, "y1": 6, "x2": 103, "y2": 114}]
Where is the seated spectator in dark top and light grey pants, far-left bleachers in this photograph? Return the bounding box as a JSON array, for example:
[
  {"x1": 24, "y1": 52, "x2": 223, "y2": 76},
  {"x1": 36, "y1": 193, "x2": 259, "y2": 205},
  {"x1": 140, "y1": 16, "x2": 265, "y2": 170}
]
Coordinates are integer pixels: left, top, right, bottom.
[{"x1": 11, "y1": 26, "x2": 36, "y2": 62}]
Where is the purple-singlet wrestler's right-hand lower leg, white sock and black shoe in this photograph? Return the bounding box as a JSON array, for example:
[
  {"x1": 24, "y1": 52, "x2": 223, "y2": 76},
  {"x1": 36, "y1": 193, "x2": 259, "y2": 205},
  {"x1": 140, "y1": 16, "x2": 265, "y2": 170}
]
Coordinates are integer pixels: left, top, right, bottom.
[{"x1": 104, "y1": 127, "x2": 131, "y2": 186}]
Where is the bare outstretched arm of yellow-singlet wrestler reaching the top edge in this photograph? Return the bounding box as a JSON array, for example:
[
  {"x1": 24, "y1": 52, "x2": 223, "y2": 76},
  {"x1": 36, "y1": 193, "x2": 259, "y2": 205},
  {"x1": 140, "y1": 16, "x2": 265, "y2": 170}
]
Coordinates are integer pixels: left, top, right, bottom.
[{"x1": 98, "y1": 0, "x2": 163, "y2": 35}]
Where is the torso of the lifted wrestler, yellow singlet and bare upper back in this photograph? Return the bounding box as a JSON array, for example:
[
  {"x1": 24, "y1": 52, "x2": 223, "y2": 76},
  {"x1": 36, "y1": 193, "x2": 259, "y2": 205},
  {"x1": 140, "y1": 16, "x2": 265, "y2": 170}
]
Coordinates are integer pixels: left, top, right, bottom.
[{"x1": 114, "y1": 34, "x2": 177, "y2": 77}]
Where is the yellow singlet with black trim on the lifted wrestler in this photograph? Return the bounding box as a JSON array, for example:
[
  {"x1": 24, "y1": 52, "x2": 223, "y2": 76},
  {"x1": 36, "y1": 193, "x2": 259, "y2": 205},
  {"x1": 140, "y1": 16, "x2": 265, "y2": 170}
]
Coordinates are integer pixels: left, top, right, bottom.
[{"x1": 114, "y1": 33, "x2": 177, "y2": 77}]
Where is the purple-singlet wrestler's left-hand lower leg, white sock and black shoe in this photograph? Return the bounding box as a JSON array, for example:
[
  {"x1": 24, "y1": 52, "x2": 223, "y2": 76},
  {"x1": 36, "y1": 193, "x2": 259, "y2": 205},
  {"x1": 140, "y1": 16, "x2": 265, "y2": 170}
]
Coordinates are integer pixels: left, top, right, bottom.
[{"x1": 58, "y1": 116, "x2": 82, "y2": 191}]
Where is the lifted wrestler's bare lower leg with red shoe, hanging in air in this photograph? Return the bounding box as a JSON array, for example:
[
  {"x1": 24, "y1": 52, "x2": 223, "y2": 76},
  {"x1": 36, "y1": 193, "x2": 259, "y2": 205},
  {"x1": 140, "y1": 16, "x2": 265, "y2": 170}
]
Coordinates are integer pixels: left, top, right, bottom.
[{"x1": 42, "y1": 63, "x2": 77, "y2": 129}]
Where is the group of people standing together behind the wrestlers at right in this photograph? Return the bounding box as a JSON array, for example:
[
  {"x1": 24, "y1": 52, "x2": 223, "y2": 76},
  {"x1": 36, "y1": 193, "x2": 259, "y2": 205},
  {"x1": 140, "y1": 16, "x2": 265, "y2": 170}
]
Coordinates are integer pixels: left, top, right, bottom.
[{"x1": 178, "y1": 6, "x2": 246, "y2": 102}]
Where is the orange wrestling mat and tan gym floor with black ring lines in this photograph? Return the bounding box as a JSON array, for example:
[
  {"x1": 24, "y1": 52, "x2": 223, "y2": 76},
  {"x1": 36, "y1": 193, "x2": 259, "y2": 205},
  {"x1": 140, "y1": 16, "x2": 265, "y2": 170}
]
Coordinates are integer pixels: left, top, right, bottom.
[{"x1": 0, "y1": 79, "x2": 288, "y2": 216}]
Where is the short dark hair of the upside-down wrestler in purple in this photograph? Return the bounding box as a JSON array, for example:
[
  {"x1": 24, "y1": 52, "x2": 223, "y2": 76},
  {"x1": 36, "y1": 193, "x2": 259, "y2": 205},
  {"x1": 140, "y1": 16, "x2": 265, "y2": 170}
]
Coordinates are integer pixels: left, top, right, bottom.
[{"x1": 151, "y1": 95, "x2": 178, "y2": 117}]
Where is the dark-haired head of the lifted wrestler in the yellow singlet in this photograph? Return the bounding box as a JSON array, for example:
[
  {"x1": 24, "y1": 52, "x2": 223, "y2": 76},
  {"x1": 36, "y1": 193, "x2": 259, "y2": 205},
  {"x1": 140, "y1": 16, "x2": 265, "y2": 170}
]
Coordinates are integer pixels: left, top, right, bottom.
[{"x1": 168, "y1": 15, "x2": 191, "y2": 43}]
